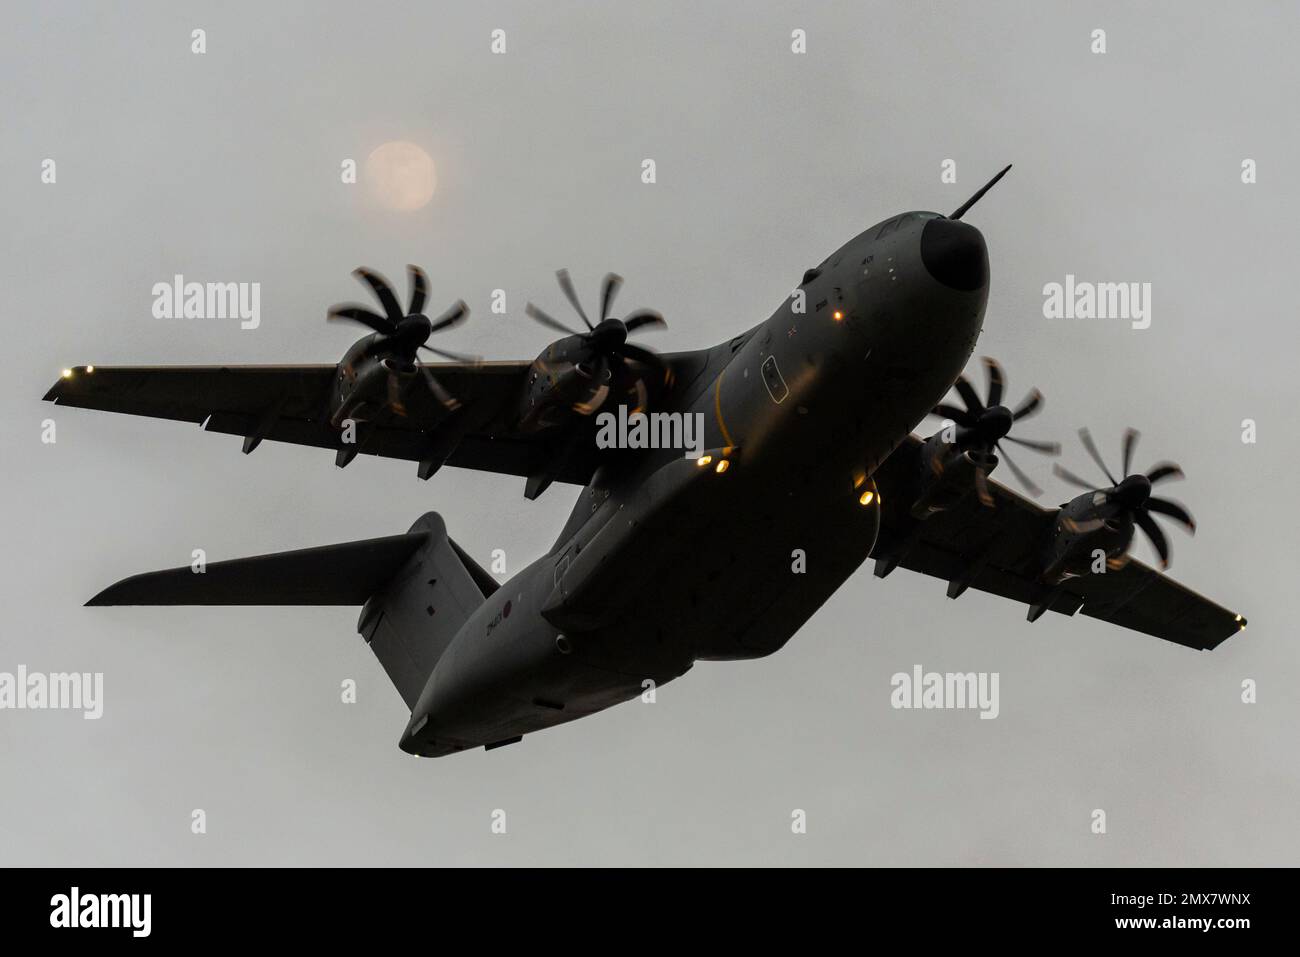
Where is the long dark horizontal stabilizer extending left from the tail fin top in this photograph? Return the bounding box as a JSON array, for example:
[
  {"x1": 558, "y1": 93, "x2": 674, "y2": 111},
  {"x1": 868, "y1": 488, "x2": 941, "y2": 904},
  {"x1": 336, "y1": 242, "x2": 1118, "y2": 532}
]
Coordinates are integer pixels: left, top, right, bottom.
[{"x1": 86, "y1": 532, "x2": 428, "y2": 605}]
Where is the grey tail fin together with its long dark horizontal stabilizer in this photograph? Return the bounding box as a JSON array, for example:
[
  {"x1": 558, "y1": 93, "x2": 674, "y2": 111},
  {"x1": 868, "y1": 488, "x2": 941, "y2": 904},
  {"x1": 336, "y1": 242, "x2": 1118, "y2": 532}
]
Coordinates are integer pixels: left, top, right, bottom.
[{"x1": 86, "y1": 512, "x2": 497, "y2": 707}]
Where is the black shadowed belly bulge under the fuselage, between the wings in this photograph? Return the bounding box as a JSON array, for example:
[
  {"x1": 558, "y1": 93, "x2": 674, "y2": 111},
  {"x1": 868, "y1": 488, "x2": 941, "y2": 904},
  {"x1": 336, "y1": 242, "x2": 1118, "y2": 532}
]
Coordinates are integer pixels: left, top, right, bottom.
[{"x1": 543, "y1": 447, "x2": 879, "y2": 665}]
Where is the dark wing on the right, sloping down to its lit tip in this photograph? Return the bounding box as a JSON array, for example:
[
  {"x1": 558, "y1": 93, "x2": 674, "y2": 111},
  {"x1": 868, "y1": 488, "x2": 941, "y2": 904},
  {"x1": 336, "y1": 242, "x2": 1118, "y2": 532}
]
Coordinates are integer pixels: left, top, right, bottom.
[{"x1": 871, "y1": 436, "x2": 1245, "y2": 650}]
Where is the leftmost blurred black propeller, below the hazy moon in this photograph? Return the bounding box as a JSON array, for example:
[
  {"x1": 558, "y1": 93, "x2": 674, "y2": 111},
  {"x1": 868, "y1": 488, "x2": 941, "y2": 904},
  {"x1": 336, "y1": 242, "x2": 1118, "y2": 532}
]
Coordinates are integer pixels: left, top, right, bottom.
[{"x1": 326, "y1": 265, "x2": 481, "y2": 408}]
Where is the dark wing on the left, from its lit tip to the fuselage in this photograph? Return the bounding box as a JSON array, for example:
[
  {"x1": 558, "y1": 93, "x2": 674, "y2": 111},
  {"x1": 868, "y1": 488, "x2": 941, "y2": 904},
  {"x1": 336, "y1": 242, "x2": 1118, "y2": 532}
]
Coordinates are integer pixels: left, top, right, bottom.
[{"x1": 44, "y1": 361, "x2": 595, "y2": 485}]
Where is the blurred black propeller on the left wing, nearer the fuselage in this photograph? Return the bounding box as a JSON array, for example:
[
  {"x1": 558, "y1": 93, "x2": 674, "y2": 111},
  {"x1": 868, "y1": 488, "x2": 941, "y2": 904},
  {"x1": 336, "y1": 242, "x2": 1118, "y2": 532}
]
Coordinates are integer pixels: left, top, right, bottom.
[{"x1": 525, "y1": 269, "x2": 668, "y2": 411}]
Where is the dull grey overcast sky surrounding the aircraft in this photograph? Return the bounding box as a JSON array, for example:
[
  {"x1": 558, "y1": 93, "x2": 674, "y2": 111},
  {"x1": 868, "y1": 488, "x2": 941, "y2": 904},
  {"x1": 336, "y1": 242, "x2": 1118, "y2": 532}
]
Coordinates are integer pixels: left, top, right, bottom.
[{"x1": 0, "y1": 0, "x2": 1300, "y2": 865}]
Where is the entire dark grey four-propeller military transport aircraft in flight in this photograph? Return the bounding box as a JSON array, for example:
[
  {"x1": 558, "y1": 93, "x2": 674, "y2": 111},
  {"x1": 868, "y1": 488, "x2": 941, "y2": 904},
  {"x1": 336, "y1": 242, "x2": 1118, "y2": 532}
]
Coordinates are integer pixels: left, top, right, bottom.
[{"x1": 46, "y1": 169, "x2": 1245, "y2": 755}]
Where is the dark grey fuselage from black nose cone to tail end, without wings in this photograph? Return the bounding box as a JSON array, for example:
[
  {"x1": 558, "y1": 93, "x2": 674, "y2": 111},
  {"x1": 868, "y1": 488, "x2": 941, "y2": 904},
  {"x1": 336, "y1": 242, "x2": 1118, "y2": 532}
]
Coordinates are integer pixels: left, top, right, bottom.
[{"x1": 400, "y1": 213, "x2": 988, "y2": 755}]
